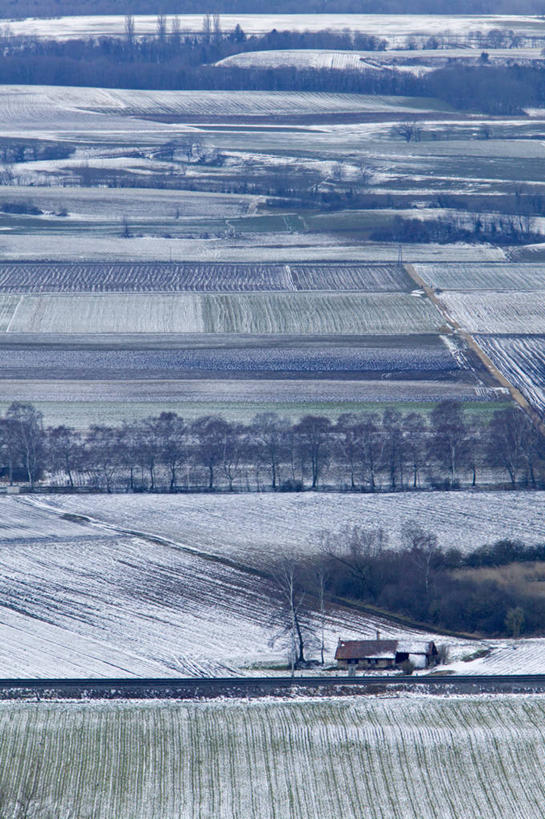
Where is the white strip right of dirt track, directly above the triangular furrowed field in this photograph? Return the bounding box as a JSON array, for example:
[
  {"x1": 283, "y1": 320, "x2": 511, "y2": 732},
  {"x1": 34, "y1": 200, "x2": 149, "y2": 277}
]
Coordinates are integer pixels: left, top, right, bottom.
[{"x1": 439, "y1": 290, "x2": 545, "y2": 335}]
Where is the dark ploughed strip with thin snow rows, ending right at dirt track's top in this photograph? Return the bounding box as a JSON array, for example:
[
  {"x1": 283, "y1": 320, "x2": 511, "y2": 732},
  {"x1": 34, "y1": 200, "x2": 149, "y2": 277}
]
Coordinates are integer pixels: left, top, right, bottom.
[{"x1": 0, "y1": 262, "x2": 412, "y2": 293}]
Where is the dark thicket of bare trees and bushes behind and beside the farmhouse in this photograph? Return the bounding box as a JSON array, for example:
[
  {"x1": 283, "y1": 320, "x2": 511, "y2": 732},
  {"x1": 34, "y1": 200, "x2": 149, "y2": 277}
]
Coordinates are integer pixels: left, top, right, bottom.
[{"x1": 268, "y1": 520, "x2": 545, "y2": 666}]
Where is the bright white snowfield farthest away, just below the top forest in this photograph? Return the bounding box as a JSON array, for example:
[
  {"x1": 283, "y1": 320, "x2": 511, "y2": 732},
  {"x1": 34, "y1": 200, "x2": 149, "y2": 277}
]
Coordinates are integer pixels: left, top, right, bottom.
[{"x1": 9, "y1": 13, "x2": 545, "y2": 45}]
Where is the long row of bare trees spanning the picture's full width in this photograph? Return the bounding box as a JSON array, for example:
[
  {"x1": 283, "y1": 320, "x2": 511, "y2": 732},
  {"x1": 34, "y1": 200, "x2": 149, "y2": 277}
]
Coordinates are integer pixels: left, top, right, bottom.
[{"x1": 0, "y1": 401, "x2": 545, "y2": 492}]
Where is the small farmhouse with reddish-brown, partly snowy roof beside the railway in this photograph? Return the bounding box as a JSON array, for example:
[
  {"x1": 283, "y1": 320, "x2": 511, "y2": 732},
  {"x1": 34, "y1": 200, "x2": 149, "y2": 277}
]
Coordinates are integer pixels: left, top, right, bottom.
[{"x1": 335, "y1": 639, "x2": 439, "y2": 671}]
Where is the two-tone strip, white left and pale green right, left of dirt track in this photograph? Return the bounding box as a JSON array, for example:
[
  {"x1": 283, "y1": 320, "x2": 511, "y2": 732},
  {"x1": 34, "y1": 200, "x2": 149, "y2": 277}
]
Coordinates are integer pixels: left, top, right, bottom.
[{"x1": 2, "y1": 292, "x2": 442, "y2": 335}]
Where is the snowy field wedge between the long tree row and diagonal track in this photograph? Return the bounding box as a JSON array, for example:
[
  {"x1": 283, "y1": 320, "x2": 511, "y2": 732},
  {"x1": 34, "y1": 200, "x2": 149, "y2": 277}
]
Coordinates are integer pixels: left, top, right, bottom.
[{"x1": 26, "y1": 492, "x2": 545, "y2": 564}]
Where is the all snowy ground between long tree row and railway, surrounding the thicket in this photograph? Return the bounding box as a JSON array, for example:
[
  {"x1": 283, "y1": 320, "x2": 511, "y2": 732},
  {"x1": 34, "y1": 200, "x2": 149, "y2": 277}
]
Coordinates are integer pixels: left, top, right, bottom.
[{"x1": 0, "y1": 493, "x2": 545, "y2": 677}]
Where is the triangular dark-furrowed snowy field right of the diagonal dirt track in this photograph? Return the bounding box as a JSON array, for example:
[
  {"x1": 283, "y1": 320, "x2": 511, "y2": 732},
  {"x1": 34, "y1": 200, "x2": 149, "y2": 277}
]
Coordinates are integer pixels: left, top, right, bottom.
[{"x1": 476, "y1": 336, "x2": 545, "y2": 413}]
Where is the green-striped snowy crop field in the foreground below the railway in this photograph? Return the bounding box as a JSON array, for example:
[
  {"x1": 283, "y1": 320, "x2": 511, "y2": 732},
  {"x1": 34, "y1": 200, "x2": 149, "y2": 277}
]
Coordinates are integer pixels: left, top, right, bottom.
[{"x1": 0, "y1": 695, "x2": 545, "y2": 819}]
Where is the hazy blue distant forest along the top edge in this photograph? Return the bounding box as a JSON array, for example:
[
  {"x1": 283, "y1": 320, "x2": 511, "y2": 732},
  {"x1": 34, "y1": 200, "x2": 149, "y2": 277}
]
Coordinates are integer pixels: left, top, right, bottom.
[{"x1": 0, "y1": 0, "x2": 545, "y2": 18}]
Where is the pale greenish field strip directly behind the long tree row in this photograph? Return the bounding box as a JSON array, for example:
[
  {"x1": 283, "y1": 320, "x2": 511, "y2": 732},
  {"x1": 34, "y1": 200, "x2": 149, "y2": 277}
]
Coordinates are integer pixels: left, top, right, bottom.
[{"x1": 0, "y1": 373, "x2": 486, "y2": 414}]
